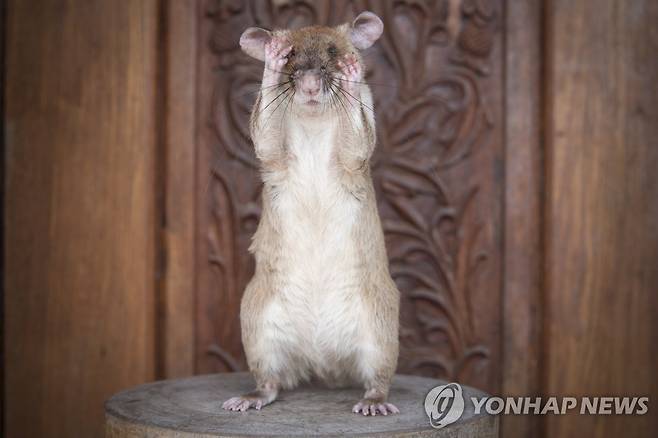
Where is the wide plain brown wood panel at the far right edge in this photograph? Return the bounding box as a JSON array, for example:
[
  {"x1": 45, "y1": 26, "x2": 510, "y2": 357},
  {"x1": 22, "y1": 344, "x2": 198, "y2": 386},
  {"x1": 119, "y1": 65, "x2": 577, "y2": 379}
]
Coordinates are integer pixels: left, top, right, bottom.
[{"x1": 544, "y1": 0, "x2": 658, "y2": 437}]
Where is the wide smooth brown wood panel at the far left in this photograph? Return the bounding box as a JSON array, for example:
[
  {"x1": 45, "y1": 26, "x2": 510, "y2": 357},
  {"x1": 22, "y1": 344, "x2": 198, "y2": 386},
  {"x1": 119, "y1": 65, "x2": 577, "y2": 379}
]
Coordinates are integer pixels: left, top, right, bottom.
[{"x1": 4, "y1": 0, "x2": 157, "y2": 438}]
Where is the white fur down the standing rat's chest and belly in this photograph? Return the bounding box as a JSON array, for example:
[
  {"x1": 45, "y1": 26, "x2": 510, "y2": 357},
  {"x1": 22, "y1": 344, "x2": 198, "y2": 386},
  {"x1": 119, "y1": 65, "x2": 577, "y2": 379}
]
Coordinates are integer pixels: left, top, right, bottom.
[{"x1": 263, "y1": 119, "x2": 364, "y2": 381}]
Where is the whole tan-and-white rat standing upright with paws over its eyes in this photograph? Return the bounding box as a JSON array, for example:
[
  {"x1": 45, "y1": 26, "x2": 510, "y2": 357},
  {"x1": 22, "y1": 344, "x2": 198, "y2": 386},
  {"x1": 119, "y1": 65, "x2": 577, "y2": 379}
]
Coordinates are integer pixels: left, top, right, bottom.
[{"x1": 223, "y1": 12, "x2": 400, "y2": 415}]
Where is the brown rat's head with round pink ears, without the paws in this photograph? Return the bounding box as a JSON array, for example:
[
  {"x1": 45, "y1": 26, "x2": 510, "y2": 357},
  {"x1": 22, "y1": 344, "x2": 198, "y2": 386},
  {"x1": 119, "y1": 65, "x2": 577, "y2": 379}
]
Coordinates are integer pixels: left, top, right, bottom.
[{"x1": 240, "y1": 12, "x2": 384, "y2": 112}]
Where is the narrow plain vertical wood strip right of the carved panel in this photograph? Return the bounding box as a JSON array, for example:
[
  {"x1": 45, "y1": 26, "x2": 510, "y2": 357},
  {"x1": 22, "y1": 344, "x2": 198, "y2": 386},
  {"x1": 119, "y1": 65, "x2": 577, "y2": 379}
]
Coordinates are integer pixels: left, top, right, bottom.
[{"x1": 501, "y1": 0, "x2": 543, "y2": 438}]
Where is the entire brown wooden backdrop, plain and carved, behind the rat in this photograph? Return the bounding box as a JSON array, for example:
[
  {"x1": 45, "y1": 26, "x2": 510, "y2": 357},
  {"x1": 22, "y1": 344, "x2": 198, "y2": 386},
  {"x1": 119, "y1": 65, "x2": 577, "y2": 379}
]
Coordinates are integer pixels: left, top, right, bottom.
[{"x1": 1, "y1": 0, "x2": 658, "y2": 438}]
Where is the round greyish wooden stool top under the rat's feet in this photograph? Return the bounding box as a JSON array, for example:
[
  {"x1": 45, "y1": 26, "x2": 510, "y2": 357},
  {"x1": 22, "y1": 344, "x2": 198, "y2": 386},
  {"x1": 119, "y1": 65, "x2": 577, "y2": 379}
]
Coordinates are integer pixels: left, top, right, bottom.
[{"x1": 105, "y1": 373, "x2": 498, "y2": 438}]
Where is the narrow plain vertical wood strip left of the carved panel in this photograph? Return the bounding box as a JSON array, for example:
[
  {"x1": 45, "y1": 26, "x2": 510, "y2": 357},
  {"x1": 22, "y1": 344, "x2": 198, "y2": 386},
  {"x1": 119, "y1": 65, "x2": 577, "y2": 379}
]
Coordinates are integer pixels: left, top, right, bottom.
[{"x1": 159, "y1": 0, "x2": 198, "y2": 378}]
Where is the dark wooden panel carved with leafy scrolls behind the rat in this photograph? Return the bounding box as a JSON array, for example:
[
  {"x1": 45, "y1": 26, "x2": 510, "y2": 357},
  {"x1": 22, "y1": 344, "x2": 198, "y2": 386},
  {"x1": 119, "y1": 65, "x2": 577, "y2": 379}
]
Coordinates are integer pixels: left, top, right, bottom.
[{"x1": 196, "y1": 0, "x2": 503, "y2": 391}]
